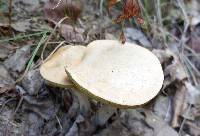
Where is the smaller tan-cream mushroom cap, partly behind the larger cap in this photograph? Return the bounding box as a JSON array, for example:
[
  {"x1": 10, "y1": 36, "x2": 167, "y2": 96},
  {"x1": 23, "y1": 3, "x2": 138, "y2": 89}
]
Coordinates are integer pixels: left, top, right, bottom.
[{"x1": 40, "y1": 45, "x2": 85, "y2": 87}]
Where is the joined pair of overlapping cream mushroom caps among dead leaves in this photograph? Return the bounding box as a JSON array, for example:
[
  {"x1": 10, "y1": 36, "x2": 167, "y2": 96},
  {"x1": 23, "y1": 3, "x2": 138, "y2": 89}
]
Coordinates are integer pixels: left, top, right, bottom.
[{"x1": 40, "y1": 40, "x2": 164, "y2": 108}]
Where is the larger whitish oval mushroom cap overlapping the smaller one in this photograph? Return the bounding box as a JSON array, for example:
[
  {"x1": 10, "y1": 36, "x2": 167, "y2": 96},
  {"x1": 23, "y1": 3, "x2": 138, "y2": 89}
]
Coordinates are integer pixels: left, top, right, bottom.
[{"x1": 66, "y1": 40, "x2": 164, "y2": 107}]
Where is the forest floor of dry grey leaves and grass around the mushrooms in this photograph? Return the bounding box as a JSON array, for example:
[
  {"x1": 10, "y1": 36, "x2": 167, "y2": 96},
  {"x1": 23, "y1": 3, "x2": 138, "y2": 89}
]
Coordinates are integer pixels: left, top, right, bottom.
[{"x1": 0, "y1": 0, "x2": 200, "y2": 136}]
